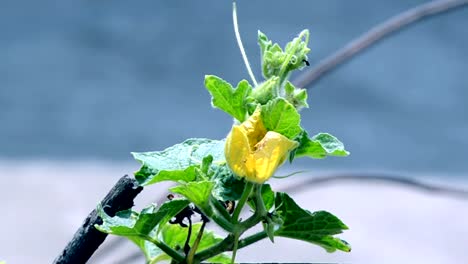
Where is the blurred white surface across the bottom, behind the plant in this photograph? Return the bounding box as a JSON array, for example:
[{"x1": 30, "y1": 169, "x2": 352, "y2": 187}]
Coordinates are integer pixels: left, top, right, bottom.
[{"x1": 0, "y1": 162, "x2": 468, "y2": 264}]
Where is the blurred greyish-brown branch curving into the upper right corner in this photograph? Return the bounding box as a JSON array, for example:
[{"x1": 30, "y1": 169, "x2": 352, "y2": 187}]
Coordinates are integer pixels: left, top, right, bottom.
[{"x1": 293, "y1": 0, "x2": 468, "y2": 87}]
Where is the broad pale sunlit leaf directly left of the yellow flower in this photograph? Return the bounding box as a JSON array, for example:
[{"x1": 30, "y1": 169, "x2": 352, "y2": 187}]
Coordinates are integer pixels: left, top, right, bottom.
[{"x1": 132, "y1": 138, "x2": 224, "y2": 186}]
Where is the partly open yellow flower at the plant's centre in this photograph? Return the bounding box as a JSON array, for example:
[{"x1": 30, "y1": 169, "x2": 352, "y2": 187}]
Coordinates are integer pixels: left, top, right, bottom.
[{"x1": 224, "y1": 108, "x2": 298, "y2": 183}]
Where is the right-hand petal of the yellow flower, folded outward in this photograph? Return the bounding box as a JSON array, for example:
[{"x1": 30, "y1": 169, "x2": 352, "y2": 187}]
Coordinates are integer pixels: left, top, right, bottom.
[{"x1": 246, "y1": 131, "x2": 298, "y2": 183}]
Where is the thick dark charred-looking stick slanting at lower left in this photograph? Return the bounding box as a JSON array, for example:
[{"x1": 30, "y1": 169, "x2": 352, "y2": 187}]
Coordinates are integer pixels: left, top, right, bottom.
[{"x1": 54, "y1": 175, "x2": 143, "y2": 264}]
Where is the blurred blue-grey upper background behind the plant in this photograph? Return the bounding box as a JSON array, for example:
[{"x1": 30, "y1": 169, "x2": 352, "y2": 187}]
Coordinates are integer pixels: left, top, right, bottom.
[{"x1": 0, "y1": 0, "x2": 468, "y2": 174}]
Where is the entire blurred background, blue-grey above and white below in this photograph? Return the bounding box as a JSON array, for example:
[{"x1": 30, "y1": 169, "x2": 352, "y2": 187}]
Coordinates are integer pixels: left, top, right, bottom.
[{"x1": 0, "y1": 0, "x2": 468, "y2": 263}]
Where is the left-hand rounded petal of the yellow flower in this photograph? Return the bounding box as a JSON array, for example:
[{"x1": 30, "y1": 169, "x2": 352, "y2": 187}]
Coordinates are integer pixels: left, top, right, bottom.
[{"x1": 224, "y1": 126, "x2": 254, "y2": 177}]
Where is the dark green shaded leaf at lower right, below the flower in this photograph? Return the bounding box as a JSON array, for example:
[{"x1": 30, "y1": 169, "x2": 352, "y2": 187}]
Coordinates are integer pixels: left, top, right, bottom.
[{"x1": 275, "y1": 193, "x2": 351, "y2": 252}]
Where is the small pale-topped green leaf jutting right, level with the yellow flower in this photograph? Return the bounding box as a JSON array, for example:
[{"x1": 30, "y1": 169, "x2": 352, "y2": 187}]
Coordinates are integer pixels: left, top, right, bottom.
[{"x1": 294, "y1": 131, "x2": 349, "y2": 159}]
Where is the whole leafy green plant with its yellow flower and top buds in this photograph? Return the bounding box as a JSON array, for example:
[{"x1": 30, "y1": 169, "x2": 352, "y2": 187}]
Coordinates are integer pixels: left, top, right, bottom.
[{"x1": 96, "y1": 6, "x2": 351, "y2": 264}]
